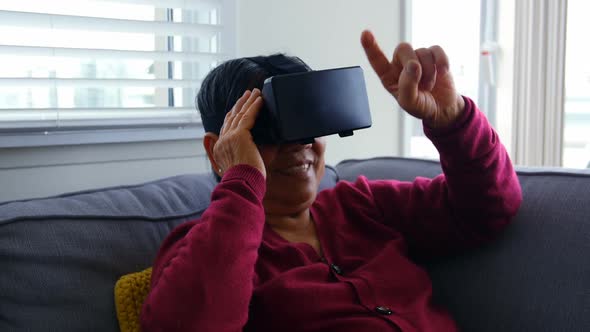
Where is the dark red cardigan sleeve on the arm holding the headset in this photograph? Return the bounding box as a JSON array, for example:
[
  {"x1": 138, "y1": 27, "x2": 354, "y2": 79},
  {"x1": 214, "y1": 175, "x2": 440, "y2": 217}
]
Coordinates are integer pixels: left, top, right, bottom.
[{"x1": 141, "y1": 165, "x2": 266, "y2": 332}]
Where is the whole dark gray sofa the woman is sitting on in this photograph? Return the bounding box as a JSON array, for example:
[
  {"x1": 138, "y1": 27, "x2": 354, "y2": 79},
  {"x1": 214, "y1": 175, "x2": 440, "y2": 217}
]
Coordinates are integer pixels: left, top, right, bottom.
[{"x1": 0, "y1": 158, "x2": 590, "y2": 332}]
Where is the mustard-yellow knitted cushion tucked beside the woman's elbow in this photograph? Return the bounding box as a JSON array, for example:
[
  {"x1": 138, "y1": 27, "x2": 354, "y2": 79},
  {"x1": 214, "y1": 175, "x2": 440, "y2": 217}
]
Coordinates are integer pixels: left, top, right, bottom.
[{"x1": 115, "y1": 267, "x2": 152, "y2": 332}]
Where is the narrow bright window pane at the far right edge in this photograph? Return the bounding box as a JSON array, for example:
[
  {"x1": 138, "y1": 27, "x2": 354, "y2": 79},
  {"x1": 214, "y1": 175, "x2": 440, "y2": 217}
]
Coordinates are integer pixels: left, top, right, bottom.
[{"x1": 563, "y1": 0, "x2": 590, "y2": 168}]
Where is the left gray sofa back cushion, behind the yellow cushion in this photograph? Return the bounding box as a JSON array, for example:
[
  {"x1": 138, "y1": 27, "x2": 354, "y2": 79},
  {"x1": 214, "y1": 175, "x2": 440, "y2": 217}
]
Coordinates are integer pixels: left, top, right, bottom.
[{"x1": 0, "y1": 167, "x2": 337, "y2": 331}]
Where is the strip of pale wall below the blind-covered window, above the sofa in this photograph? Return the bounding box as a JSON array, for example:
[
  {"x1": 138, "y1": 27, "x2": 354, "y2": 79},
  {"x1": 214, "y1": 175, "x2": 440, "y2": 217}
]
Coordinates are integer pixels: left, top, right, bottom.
[{"x1": 0, "y1": 138, "x2": 208, "y2": 202}]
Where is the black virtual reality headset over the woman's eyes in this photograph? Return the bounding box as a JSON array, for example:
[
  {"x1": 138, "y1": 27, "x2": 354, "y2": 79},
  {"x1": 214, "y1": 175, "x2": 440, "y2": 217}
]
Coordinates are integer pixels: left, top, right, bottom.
[{"x1": 252, "y1": 66, "x2": 372, "y2": 144}]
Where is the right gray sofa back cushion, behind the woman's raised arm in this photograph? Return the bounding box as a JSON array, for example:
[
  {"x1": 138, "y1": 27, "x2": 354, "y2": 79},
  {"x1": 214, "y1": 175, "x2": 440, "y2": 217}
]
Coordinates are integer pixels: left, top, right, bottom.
[{"x1": 336, "y1": 158, "x2": 590, "y2": 332}]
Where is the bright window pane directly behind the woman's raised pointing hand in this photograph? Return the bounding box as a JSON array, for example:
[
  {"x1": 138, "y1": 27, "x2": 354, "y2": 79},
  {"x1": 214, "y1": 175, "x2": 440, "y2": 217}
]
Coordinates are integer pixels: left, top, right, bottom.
[{"x1": 404, "y1": 0, "x2": 499, "y2": 159}]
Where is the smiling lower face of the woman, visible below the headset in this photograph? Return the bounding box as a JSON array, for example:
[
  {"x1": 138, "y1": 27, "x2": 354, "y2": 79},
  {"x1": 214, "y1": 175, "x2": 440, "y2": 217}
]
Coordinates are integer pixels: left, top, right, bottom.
[{"x1": 258, "y1": 138, "x2": 326, "y2": 215}]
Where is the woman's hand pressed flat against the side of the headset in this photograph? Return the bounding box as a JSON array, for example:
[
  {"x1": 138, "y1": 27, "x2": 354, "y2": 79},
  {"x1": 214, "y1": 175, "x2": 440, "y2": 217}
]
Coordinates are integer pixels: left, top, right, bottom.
[{"x1": 213, "y1": 89, "x2": 266, "y2": 177}]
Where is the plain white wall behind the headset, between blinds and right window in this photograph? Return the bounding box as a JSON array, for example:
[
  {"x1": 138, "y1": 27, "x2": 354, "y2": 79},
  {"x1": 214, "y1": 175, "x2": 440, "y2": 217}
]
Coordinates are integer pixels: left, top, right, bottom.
[{"x1": 237, "y1": 0, "x2": 401, "y2": 164}]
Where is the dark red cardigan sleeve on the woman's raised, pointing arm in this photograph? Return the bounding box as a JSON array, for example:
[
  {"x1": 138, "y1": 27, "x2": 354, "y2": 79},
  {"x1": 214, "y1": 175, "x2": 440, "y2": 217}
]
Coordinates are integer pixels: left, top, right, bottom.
[{"x1": 368, "y1": 98, "x2": 522, "y2": 258}]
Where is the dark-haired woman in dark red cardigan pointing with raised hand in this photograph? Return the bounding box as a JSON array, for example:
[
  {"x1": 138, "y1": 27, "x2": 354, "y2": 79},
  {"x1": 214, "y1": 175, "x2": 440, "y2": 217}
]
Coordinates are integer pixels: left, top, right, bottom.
[{"x1": 141, "y1": 31, "x2": 521, "y2": 332}]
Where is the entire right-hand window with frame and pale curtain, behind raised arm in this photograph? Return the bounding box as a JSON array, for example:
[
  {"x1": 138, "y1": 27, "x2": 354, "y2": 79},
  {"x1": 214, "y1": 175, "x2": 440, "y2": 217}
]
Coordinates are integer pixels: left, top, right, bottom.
[{"x1": 404, "y1": 0, "x2": 590, "y2": 168}]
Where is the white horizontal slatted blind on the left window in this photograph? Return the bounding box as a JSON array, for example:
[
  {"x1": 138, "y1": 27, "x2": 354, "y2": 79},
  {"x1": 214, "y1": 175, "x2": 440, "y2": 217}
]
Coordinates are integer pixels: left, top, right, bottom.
[{"x1": 0, "y1": 0, "x2": 235, "y2": 144}]
